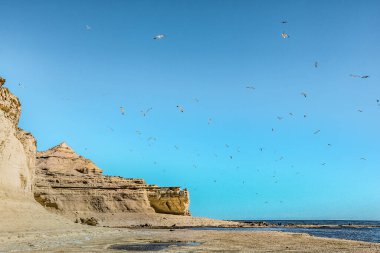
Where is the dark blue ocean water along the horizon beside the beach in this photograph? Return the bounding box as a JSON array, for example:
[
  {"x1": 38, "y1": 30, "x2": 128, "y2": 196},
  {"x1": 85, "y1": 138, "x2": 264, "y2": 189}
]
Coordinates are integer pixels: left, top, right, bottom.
[{"x1": 195, "y1": 220, "x2": 380, "y2": 243}]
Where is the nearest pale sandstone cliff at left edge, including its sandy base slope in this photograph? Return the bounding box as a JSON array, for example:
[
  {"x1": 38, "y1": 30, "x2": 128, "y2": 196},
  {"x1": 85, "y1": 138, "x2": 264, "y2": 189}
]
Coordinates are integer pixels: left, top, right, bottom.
[{"x1": 0, "y1": 77, "x2": 72, "y2": 232}]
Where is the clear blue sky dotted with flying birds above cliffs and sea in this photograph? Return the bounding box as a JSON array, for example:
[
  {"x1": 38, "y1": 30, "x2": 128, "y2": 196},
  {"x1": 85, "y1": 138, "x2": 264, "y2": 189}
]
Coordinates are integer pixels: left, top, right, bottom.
[{"x1": 0, "y1": 0, "x2": 380, "y2": 220}]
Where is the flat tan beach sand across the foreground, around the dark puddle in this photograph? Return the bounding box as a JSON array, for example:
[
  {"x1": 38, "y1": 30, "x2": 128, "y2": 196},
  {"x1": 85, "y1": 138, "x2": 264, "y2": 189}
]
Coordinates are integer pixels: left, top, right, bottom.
[{"x1": 0, "y1": 225, "x2": 380, "y2": 252}]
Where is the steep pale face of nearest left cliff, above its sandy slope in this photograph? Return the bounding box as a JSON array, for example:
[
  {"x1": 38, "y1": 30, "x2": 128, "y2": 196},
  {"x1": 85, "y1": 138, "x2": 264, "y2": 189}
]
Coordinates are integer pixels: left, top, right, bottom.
[{"x1": 0, "y1": 78, "x2": 36, "y2": 194}]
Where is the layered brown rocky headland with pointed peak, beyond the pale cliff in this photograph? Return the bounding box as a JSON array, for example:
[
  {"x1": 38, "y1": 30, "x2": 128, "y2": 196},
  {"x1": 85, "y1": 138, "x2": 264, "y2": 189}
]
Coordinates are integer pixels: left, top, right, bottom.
[{"x1": 34, "y1": 143, "x2": 189, "y2": 218}]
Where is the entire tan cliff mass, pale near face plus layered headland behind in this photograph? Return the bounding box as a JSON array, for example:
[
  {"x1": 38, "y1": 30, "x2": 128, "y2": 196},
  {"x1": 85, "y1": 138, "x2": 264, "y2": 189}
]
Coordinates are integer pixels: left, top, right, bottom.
[{"x1": 0, "y1": 77, "x2": 189, "y2": 232}]
